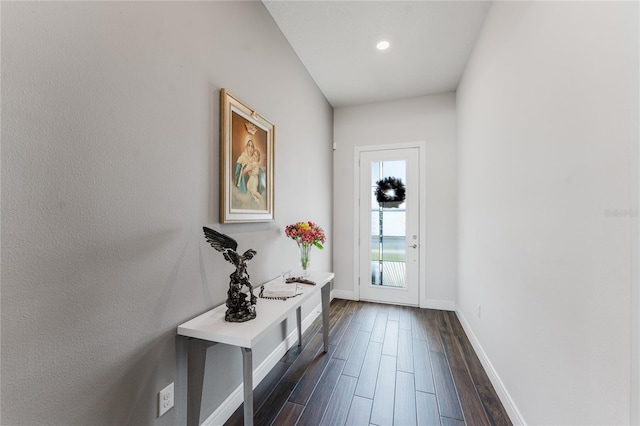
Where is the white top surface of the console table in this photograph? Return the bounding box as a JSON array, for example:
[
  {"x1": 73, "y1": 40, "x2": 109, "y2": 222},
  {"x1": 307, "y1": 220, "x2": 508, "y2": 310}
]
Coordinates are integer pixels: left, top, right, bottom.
[{"x1": 178, "y1": 272, "x2": 334, "y2": 348}]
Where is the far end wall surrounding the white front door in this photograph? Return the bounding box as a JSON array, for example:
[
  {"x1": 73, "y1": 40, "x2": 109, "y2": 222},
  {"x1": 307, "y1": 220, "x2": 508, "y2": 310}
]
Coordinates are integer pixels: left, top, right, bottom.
[{"x1": 333, "y1": 93, "x2": 456, "y2": 309}]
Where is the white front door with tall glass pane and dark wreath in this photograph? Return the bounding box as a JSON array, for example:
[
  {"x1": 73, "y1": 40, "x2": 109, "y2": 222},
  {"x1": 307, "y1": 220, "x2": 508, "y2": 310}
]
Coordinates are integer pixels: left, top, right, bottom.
[{"x1": 358, "y1": 147, "x2": 420, "y2": 306}]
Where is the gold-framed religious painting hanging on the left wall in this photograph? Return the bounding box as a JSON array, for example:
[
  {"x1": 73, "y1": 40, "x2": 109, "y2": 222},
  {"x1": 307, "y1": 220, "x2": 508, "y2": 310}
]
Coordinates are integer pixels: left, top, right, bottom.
[{"x1": 220, "y1": 89, "x2": 275, "y2": 223}]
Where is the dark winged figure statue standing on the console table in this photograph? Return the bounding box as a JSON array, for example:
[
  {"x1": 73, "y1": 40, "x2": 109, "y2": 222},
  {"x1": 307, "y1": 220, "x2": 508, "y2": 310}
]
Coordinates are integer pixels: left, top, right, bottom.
[{"x1": 202, "y1": 226, "x2": 257, "y2": 322}]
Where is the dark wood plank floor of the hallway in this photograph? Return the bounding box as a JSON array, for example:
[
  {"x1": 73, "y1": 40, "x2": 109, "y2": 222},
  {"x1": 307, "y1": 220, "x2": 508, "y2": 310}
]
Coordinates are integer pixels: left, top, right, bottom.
[{"x1": 226, "y1": 299, "x2": 511, "y2": 426}]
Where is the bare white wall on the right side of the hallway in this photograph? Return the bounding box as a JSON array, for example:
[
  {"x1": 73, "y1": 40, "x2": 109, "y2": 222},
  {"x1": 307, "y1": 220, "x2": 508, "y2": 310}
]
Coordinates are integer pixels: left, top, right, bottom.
[{"x1": 457, "y1": 2, "x2": 639, "y2": 425}]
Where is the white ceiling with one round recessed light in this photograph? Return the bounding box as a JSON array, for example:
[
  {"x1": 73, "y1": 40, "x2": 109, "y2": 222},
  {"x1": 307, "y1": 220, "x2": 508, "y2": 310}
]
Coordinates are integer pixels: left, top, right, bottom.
[{"x1": 263, "y1": 0, "x2": 491, "y2": 107}]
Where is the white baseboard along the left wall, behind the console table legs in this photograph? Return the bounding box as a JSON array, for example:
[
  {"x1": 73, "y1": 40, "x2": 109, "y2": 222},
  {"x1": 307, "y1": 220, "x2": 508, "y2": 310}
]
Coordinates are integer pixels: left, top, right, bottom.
[{"x1": 201, "y1": 304, "x2": 322, "y2": 426}]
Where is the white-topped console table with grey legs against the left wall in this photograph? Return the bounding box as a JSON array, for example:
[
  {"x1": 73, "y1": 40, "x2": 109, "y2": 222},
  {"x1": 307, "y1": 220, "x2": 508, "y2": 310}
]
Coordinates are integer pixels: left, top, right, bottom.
[{"x1": 178, "y1": 272, "x2": 334, "y2": 426}]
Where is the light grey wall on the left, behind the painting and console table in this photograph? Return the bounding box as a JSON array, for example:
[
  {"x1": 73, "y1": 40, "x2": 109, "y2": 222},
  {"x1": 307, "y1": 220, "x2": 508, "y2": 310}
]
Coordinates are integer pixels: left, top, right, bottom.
[{"x1": 1, "y1": 1, "x2": 333, "y2": 425}]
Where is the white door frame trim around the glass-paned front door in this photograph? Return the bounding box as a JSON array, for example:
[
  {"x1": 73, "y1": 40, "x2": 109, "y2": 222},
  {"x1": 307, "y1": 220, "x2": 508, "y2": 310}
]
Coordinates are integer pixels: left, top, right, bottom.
[{"x1": 353, "y1": 141, "x2": 427, "y2": 308}]
